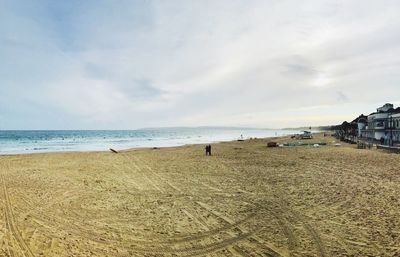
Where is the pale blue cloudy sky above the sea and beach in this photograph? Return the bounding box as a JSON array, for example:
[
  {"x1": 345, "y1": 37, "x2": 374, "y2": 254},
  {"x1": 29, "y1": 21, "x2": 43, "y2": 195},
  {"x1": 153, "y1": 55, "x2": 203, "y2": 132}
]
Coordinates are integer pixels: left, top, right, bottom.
[{"x1": 0, "y1": 0, "x2": 400, "y2": 129}]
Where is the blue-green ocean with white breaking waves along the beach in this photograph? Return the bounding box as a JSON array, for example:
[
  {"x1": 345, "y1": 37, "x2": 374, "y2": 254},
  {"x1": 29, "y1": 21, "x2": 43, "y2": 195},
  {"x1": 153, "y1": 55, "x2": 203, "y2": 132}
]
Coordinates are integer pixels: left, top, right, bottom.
[{"x1": 0, "y1": 127, "x2": 299, "y2": 154}]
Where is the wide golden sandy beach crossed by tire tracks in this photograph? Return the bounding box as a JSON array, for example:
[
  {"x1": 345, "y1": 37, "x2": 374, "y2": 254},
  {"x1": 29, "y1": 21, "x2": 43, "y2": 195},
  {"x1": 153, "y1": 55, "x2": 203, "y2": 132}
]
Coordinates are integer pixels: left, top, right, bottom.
[{"x1": 0, "y1": 134, "x2": 400, "y2": 257}]
